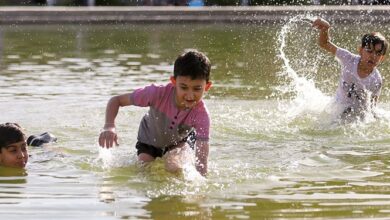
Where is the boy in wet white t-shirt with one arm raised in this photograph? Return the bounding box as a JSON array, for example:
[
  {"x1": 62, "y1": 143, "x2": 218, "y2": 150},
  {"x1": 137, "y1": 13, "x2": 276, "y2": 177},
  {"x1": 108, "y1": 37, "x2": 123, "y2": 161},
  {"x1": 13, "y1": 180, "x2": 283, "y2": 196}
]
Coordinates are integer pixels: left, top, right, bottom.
[{"x1": 313, "y1": 18, "x2": 388, "y2": 119}]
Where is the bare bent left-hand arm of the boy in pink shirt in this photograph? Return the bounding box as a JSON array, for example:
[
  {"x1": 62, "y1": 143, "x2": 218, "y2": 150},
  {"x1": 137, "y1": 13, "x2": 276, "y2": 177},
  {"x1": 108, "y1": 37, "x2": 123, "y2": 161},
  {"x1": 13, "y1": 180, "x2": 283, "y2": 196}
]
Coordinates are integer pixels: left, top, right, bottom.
[{"x1": 99, "y1": 93, "x2": 132, "y2": 148}]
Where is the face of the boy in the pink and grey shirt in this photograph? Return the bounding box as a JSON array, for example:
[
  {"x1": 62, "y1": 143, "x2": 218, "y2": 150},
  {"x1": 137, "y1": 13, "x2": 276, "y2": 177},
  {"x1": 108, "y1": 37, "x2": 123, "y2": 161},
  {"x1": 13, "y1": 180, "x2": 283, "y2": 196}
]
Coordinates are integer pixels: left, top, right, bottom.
[{"x1": 171, "y1": 76, "x2": 211, "y2": 109}]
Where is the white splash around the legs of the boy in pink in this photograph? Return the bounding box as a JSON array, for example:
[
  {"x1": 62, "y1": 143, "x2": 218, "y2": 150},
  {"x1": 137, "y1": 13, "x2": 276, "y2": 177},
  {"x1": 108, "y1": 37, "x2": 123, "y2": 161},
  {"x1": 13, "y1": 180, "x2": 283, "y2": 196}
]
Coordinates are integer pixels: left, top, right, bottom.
[{"x1": 93, "y1": 144, "x2": 207, "y2": 197}]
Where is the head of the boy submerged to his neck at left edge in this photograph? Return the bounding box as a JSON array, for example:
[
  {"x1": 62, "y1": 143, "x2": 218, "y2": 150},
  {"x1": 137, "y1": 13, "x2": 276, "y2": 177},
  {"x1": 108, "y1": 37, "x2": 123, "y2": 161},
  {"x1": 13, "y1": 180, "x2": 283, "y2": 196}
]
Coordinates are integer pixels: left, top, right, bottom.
[{"x1": 0, "y1": 123, "x2": 28, "y2": 168}]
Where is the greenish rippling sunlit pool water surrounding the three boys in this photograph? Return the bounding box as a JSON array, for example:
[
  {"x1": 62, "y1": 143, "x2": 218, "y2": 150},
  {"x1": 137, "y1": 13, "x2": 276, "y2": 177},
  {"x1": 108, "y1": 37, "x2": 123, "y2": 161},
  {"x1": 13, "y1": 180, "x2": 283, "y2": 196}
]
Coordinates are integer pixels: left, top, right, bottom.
[{"x1": 0, "y1": 15, "x2": 390, "y2": 219}]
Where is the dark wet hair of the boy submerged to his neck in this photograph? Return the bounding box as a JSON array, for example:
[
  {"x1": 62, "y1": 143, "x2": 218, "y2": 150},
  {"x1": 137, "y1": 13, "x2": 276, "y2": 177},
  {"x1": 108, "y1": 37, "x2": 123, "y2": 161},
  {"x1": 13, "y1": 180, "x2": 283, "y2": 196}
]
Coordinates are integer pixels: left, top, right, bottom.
[{"x1": 0, "y1": 123, "x2": 26, "y2": 152}]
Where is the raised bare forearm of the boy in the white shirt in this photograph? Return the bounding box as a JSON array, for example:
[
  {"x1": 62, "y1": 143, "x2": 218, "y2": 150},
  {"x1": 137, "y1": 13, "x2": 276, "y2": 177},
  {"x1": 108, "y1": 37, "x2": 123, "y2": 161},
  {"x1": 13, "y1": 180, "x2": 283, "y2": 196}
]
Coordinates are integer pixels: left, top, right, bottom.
[{"x1": 313, "y1": 18, "x2": 337, "y2": 55}]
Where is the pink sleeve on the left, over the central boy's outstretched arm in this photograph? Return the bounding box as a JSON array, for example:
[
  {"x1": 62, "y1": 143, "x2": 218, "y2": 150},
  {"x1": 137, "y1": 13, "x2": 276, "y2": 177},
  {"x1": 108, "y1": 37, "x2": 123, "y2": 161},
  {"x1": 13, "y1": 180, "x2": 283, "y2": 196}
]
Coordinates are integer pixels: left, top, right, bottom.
[{"x1": 130, "y1": 84, "x2": 163, "y2": 107}]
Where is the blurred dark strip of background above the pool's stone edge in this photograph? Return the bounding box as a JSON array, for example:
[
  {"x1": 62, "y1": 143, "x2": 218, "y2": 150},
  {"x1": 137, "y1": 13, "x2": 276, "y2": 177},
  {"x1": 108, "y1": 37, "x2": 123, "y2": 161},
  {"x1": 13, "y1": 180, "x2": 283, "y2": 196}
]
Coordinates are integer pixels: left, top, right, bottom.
[{"x1": 0, "y1": 0, "x2": 390, "y2": 6}]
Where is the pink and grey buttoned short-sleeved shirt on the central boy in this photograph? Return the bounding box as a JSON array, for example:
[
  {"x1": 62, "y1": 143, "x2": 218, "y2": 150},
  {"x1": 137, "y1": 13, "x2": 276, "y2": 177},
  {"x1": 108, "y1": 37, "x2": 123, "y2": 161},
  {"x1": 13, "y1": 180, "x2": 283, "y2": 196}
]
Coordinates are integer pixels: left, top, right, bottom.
[{"x1": 130, "y1": 83, "x2": 210, "y2": 148}]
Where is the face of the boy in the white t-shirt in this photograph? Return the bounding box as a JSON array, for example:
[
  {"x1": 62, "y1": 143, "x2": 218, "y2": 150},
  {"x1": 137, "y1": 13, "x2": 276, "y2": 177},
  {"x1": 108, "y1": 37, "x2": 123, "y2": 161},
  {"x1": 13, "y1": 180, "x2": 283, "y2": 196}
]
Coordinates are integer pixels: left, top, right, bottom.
[{"x1": 359, "y1": 44, "x2": 385, "y2": 69}]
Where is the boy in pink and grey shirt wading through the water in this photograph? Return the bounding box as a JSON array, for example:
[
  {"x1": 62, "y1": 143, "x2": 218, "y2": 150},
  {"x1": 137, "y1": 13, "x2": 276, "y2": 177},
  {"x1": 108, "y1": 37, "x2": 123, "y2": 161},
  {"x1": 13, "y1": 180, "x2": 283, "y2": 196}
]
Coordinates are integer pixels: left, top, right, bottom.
[{"x1": 99, "y1": 50, "x2": 211, "y2": 176}]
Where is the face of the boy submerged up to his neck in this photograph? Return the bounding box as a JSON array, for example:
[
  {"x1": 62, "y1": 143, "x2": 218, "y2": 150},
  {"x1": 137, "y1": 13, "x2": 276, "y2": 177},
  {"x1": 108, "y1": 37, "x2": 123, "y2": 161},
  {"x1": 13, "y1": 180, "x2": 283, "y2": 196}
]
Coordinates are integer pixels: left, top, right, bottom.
[{"x1": 0, "y1": 141, "x2": 28, "y2": 168}]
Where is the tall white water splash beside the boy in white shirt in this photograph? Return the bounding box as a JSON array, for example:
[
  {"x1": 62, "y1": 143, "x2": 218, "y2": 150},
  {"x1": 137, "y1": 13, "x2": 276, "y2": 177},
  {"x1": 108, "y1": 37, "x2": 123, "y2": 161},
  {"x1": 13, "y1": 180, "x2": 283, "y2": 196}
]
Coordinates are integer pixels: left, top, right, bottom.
[{"x1": 277, "y1": 15, "x2": 389, "y2": 128}]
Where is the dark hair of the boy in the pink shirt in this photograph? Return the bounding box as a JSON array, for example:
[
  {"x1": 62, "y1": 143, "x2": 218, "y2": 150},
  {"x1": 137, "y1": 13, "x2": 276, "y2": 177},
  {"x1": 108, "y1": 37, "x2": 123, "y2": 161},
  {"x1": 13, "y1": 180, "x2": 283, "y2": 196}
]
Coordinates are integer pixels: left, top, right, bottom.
[{"x1": 173, "y1": 50, "x2": 211, "y2": 82}]
